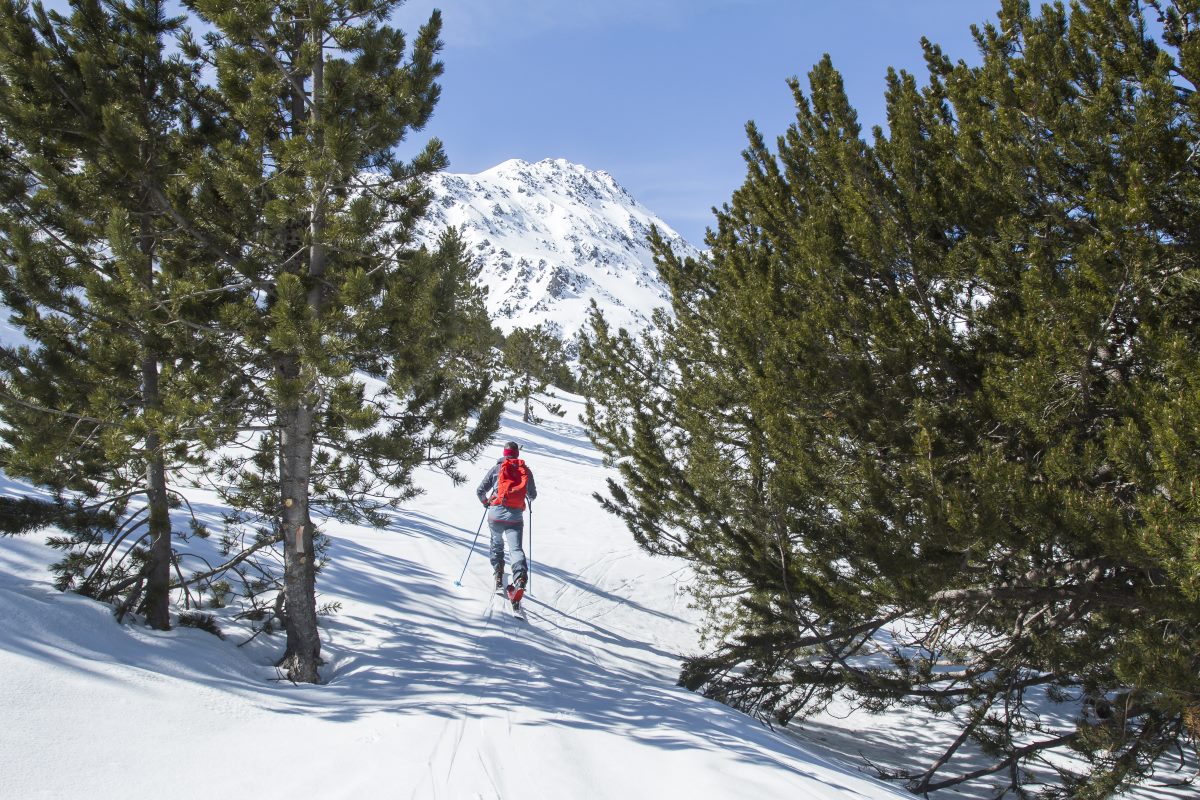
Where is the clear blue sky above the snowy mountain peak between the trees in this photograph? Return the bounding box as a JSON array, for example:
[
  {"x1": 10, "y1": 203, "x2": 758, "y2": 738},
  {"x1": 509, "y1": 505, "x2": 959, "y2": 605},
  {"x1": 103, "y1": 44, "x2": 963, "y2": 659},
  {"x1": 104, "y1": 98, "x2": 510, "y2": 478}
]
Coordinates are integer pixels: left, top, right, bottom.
[{"x1": 395, "y1": 0, "x2": 1000, "y2": 245}]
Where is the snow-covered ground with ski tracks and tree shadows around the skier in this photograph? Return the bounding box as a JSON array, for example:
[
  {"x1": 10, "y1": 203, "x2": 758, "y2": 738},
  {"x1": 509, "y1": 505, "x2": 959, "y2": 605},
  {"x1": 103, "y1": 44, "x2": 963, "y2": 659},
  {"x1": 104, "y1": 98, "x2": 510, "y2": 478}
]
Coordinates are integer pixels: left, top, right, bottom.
[{"x1": 0, "y1": 397, "x2": 926, "y2": 800}]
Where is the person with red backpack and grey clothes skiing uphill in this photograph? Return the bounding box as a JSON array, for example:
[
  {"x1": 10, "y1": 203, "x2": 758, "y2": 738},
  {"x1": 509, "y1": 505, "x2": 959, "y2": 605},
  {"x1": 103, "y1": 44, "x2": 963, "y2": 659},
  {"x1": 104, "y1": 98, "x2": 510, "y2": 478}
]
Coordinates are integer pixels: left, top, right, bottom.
[{"x1": 475, "y1": 441, "x2": 538, "y2": 612}]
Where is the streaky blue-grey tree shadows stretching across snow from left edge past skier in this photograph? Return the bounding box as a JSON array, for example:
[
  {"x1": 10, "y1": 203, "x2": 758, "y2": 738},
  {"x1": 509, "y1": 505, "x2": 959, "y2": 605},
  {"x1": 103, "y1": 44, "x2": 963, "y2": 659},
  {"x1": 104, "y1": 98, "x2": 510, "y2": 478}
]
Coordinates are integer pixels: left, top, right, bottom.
[{"x1": 0, "y1": 472, "x2": 883, "y2": 781}]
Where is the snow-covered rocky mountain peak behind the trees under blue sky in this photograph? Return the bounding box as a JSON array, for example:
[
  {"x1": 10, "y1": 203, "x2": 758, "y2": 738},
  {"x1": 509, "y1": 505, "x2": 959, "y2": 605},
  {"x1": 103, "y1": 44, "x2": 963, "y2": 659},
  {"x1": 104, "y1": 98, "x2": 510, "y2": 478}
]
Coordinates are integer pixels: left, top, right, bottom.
[{"x1": 421, "y1": 158, "x2": 698, "y2": 339}]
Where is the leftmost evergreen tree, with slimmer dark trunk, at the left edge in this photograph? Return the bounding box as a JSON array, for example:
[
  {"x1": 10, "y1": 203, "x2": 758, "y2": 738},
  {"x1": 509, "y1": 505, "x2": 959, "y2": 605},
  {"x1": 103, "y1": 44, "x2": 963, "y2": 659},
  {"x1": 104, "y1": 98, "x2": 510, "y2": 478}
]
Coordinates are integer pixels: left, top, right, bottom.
[{"x1": 0, "y1": 0, "x2": 238, "y2": 628}]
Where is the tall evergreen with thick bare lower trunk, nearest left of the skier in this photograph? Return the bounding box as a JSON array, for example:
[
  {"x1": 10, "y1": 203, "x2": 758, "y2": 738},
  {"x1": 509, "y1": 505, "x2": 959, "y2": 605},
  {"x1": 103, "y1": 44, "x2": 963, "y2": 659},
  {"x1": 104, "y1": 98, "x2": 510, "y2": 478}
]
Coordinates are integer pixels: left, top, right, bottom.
[{"x1": 185, "y1": 0, "x2": 500, "y2": 681}]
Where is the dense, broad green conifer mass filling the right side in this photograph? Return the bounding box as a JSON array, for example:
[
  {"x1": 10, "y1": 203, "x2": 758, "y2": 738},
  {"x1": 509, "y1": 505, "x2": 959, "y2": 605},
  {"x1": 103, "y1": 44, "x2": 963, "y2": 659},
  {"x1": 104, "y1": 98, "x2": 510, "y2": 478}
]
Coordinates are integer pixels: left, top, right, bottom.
[{"x1": 582, "y1": 0, "x2": 1200, "y2": 798}]
